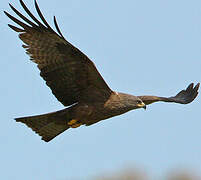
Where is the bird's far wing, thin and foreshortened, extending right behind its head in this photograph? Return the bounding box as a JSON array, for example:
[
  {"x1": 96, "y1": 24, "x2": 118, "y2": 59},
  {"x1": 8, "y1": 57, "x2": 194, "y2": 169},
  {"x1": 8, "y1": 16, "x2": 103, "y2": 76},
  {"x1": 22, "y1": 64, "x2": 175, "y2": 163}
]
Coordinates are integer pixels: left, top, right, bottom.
[{"x1": 138, "y1": 83, "x2": 200, "y2": 105}]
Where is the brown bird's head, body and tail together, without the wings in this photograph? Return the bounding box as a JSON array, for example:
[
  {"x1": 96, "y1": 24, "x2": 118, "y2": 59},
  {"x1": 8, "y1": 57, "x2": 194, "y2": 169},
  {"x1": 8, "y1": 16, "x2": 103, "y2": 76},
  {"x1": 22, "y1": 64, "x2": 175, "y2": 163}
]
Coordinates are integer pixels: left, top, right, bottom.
[{"x1": 16, "y1": 92, "x2": 146, "y2": 141}]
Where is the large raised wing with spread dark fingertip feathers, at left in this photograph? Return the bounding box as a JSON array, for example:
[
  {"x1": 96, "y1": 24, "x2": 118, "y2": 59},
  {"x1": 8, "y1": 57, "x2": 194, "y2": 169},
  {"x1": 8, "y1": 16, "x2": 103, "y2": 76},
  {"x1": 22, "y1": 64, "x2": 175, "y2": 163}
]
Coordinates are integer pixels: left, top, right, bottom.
[{"x1": 5, "y1": 0, "x2": 112, "y2": 106}]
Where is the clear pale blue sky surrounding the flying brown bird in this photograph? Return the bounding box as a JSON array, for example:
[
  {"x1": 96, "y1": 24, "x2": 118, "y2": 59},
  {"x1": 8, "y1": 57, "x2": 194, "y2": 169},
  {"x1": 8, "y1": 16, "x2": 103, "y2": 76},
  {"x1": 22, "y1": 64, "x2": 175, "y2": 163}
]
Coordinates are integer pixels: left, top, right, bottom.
[{"x1": 0, "y1": 0, "x2": 201, "y2": 180}]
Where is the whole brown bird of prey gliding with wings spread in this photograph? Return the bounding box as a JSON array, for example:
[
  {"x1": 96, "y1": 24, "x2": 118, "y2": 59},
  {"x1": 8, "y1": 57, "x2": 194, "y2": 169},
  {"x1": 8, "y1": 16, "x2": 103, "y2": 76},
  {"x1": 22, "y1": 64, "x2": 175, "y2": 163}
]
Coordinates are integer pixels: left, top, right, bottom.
[{"x1": 4, "y1": 0, "x2": 200, "y2": 142}]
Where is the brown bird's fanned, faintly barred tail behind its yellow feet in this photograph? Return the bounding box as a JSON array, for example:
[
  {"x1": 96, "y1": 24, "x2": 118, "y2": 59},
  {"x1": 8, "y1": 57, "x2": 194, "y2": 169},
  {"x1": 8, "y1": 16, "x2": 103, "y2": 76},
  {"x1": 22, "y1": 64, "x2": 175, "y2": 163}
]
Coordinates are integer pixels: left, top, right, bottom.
[{"x1": 15, "y1": 109, "x2": 70, "y2": 142}]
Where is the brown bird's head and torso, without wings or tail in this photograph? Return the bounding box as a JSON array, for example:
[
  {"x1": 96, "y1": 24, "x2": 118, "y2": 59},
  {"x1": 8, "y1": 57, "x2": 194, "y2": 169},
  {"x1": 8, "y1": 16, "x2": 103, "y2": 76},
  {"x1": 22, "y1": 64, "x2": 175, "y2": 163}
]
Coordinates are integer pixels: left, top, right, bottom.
[{"x1": 71, "y1": 92, "x2": 145, "y2": 126}]
